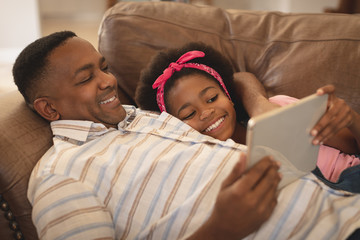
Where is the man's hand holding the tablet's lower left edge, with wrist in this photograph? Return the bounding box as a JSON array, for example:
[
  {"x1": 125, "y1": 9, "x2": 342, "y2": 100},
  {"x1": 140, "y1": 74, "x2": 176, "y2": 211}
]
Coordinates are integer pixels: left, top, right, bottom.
[{"x1": 190, "y1": 155, "x2": 281, "y2": 239}]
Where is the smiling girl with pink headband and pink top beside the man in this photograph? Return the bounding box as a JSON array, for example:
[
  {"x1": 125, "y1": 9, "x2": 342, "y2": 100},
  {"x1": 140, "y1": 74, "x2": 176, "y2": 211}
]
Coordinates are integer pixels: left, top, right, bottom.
[{"x1": 135, "y1": 43, "x2": 360, "y2": 189}]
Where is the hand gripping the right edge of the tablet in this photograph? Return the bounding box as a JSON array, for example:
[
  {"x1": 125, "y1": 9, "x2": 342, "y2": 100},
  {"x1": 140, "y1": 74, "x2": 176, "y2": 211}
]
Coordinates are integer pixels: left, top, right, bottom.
[{"x1": 311, "y1": 85, "x2": 360, "y2": 153}]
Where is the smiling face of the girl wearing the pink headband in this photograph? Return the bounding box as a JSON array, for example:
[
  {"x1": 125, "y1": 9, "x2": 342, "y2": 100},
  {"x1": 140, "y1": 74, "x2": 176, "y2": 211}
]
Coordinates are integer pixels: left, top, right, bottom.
[{"x1": 166, "y1": 74, "x2": 236, "y2": 140}]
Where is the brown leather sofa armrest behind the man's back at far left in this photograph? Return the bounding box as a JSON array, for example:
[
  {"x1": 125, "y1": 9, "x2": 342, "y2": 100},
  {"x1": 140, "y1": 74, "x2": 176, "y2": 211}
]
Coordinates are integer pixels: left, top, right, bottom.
[{"x1": 0, "y1": 91, "x2": 52, "y2": 239}]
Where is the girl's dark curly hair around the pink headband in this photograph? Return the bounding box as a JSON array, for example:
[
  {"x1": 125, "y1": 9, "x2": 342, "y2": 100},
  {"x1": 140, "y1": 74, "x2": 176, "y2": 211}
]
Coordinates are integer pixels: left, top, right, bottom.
[{"x1": 135, "y1": 42, "x2": 249, "y2": 123}]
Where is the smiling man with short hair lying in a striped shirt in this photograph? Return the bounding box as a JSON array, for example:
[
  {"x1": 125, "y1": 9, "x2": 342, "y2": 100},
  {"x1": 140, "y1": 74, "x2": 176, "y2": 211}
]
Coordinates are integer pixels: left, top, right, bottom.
[{"x1": 13, "y1": 32, "x2": 360, "y2": 239}]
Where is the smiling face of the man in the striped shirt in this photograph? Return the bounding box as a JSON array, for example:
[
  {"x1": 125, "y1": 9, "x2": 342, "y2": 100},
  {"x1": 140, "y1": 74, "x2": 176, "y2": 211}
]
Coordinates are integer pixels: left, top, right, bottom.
[{"x1": 45, "y1": 37, "x2": 126, "y2": 127}]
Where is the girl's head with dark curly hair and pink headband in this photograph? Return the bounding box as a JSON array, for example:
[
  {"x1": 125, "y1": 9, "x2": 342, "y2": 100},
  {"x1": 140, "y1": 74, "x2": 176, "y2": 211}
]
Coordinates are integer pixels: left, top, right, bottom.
[{"x1": 135, "y1": 43, "x2": 249, "y2": 144}]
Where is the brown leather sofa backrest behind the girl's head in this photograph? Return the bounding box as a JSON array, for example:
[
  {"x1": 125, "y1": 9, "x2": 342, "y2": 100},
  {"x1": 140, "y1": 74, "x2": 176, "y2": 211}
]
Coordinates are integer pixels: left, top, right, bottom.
[{"x1": 99, "y1": 2, "x2": 360, "y2": 112}]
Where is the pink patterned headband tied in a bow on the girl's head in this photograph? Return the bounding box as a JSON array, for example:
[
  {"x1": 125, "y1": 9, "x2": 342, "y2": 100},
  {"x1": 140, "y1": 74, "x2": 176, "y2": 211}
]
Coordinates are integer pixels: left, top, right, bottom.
[{"x1": 152, "y1": 51, "x2": 231, "y2": 112}]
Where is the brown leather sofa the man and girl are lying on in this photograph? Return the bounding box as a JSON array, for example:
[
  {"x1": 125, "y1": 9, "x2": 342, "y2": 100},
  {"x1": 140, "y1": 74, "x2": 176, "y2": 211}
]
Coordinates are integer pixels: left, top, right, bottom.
[{"x1": 0, "y1": 2, "x2": 360, "y2": 239}]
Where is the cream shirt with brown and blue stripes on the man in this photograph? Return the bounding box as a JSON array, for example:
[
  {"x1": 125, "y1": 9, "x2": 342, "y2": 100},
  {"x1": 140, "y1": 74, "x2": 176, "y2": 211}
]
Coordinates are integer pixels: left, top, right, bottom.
[{"x1": 28, "y1": 107, "x2": 360, "y2": 240}]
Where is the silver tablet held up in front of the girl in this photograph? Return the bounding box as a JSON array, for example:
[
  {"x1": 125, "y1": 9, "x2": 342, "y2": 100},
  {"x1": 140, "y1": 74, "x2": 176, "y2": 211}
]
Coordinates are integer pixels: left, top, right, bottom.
[{"x1": 246, "y1": 94, "x2": 328, "y2": 188}]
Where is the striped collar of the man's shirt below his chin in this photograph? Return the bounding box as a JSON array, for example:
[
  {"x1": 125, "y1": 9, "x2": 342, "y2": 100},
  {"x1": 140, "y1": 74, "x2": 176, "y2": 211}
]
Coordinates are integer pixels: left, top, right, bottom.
[{"x1": 50, "y1": 105, "x2": 136, "y2": 142}]
